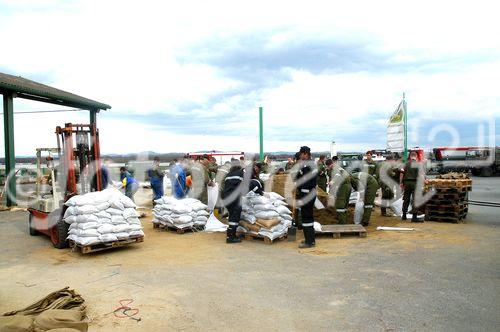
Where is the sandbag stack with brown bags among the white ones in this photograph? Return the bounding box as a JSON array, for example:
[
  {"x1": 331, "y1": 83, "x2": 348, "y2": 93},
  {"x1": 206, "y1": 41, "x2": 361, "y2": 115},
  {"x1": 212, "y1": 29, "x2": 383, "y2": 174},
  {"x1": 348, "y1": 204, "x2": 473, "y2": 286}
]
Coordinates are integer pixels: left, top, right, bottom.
[{"x1": 239, "y1": 192, "x2": 292, "y2": 240}]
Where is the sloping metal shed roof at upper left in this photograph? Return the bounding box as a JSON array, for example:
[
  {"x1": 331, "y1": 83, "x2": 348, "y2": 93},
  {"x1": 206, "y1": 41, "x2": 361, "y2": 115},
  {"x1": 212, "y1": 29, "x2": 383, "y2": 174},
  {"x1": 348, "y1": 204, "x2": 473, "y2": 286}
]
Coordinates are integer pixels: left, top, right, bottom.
[{"x1": 0, "y1": 73, "x2": 111, "y2": 110}]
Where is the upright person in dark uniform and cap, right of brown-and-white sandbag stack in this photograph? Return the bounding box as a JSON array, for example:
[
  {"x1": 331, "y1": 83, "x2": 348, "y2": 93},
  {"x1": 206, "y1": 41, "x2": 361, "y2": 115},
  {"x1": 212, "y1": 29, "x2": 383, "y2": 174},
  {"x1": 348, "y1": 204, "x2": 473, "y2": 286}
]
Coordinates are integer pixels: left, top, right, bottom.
[{"x1": 295, "y1": 146, "x2": 317, "y2": 248}]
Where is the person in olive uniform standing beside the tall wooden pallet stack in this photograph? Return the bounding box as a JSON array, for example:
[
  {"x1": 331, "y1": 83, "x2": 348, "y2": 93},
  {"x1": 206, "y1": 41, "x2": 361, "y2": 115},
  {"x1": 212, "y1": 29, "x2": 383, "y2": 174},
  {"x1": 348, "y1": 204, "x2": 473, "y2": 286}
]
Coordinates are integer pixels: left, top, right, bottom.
[{"x1": 400, "y1": 152, "x2": 423, "y2": 222}]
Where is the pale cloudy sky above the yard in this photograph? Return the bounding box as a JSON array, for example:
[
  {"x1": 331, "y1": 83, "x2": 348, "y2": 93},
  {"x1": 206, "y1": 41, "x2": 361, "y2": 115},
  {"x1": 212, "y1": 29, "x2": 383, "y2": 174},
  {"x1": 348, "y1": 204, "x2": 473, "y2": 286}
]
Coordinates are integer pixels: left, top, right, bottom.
[{"x1": 0, "y1": 0, "x2": 500, "y2": 156}]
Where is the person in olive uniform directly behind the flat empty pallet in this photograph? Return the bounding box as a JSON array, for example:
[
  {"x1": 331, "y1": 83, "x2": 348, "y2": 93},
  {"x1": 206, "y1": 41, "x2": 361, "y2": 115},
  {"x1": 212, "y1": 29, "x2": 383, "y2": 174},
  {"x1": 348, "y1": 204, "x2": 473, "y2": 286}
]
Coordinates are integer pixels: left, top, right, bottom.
[{"x1": 326, "y1": 156, "x2": 352, "y2": 225}]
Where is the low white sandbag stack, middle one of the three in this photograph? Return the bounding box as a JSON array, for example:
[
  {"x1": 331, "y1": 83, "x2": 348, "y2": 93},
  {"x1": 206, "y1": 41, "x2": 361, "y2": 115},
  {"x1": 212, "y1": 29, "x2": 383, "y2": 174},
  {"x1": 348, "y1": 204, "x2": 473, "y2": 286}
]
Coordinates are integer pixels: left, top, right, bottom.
[{"x1": 153, "y1": 196, "x2": 210, "y2": 229}]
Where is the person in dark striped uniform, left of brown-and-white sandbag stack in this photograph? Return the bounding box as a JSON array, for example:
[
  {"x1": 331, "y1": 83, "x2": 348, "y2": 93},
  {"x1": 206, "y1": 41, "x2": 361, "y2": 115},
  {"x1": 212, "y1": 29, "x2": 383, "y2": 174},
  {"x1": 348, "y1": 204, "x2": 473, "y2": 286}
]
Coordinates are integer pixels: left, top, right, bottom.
[{"x1": 222, "y1": 160, "x2": 244, "y2": 243}]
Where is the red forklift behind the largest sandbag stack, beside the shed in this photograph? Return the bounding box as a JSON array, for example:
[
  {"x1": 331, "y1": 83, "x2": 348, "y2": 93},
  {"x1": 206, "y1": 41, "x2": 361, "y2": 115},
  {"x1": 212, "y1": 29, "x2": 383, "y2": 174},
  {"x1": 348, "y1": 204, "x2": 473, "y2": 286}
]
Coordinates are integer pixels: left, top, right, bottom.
[{"x1": 28, "y1": 123, "x2": 102, "y2": 249}]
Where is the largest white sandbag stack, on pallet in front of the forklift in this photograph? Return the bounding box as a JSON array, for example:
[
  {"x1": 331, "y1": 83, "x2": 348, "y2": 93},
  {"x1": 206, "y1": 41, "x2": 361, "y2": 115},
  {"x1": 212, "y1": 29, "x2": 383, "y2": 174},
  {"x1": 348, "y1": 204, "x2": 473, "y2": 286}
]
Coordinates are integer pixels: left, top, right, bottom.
[{"x1": 64, "y1": 188, "x2": 144, "y2": 245}]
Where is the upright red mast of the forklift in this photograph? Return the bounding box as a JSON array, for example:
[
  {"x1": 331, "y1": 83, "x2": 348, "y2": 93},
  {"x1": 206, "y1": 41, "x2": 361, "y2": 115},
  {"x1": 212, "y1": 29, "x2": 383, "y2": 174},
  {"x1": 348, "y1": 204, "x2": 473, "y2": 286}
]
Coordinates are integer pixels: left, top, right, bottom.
[{"x1": 56, "y1": 123, "x2": 102, "y2": 201}]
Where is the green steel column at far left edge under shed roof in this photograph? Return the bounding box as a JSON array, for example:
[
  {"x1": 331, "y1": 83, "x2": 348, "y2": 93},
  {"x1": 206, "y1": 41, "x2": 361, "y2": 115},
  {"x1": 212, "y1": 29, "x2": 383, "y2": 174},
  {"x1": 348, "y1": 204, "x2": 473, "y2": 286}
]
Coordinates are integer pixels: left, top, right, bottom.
[{"x1": 3, "y1": 93, "x2": 16, "y2": 206}]
